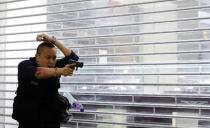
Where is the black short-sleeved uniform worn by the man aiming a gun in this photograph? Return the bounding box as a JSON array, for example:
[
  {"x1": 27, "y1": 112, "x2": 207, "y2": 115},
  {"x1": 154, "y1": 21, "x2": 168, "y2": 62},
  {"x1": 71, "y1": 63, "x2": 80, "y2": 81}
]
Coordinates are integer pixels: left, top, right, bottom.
[{"x1": 12, "y1": 52, "x2": 79, "y2": 128}]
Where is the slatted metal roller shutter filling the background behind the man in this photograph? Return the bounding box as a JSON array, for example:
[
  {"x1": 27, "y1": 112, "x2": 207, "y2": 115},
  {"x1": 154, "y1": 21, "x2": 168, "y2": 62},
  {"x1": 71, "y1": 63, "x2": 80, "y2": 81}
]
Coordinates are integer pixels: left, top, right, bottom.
[{"x1": 0, "y1": 0, "x2": 210, "y2": 128}]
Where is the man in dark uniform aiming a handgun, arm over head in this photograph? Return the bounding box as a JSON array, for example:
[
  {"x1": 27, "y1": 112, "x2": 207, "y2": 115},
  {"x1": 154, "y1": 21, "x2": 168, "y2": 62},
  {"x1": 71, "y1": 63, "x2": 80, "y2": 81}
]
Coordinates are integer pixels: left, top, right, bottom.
[{"x1": 12, "y1": 34, "x2": 79, "y2": 128}]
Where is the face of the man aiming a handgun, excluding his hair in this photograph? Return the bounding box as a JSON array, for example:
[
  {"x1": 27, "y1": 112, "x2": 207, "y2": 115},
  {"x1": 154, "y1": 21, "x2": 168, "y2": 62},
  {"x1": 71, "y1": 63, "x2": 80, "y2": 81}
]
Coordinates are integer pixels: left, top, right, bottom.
[{"x1": 36, "y1": 47, "x2": 56, "y2": 68}]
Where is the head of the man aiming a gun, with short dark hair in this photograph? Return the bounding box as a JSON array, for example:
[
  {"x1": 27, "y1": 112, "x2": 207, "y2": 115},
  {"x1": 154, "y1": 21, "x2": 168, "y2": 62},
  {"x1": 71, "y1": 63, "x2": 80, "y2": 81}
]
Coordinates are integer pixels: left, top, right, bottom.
[{"x1": 36, "y1": 42, "x2": 56, "y2": 67}]
